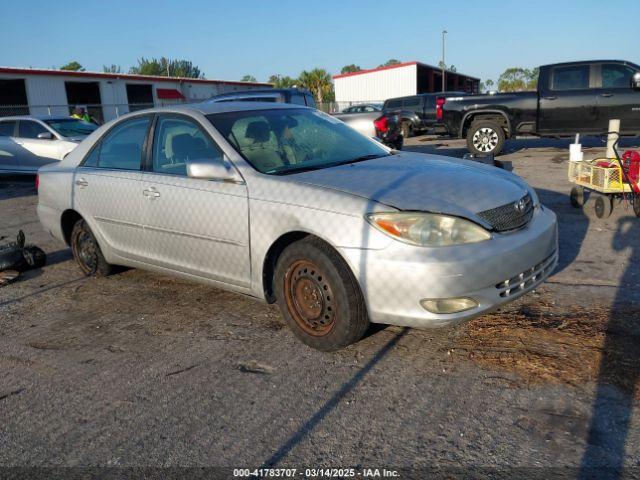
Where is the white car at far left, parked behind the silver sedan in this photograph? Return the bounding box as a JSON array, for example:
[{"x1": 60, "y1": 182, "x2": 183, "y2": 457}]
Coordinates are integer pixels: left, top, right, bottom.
[{"x1": 0, "y1": 116, "x2": 97, "y2": 175}]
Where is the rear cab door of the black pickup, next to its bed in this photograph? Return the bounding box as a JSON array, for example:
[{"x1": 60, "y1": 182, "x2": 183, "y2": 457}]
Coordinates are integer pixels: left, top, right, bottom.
[{"x1": 539, "y1": 64, "x2": 600, "y2": 135}]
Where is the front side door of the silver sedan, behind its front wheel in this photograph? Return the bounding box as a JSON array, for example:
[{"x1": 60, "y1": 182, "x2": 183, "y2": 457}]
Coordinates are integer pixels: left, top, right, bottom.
[{"x1": 142, "y1": 115, "x2": 250, "y2": 287}]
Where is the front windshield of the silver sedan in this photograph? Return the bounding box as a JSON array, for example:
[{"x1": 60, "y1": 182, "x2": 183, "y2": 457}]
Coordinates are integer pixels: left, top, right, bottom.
[{"x1": 207, "y1": 108, "x2": 389, "y2": 175}]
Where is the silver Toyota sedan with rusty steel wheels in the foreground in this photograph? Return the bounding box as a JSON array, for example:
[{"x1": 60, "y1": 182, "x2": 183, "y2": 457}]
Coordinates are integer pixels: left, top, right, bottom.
[{"x1": 38, "y1": 102, "x2": 558, "y2": 350}]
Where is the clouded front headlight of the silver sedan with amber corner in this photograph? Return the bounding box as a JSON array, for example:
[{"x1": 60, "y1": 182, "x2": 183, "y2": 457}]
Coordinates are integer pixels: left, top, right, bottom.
[{"x1": 366, "y1": 212, "x2": 491, "y2": 247}]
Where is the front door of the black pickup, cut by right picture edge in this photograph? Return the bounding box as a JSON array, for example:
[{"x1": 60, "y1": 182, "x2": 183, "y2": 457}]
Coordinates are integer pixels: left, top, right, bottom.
[{"x1": 596, "y1": 63, "x2": 640, "y2": 133}]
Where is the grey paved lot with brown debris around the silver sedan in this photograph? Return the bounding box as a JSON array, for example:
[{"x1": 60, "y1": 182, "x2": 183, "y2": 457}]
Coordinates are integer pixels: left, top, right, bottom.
[{"x1": 0, "y1": 137, "x2": 640, "y2": 478}]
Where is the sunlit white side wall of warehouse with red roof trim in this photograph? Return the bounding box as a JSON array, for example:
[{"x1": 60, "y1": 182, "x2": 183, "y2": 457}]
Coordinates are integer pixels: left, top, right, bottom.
[{"x1": 333, "y1": 65, "x2": 418, "y2": 102}]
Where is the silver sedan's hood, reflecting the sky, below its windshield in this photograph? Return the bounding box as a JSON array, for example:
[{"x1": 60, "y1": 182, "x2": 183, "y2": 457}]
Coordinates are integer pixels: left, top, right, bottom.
[{"x1": 290, "y1": 152, "x2": 529, "y2": 223}]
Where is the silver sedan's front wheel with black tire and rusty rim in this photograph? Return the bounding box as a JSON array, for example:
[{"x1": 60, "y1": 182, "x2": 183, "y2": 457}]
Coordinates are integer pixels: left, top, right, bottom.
[{"x1": 274, "y1": 237, "x2": 369, "y2": 351}]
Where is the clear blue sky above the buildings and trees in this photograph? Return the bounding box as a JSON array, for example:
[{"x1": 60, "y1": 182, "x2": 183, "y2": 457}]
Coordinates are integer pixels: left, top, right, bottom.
[{"x1": 0, "y1": 0, "x2": 640, "y2": 80}]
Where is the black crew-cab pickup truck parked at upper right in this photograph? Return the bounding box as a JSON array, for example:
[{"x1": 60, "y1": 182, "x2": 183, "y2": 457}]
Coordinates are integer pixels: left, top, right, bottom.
[{"x1": 439, "y1": 60, "x2": 640, "y2": 155}]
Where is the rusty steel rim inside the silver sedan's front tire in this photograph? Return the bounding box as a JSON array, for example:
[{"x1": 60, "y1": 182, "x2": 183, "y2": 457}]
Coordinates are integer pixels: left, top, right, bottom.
[{"x1": 284, "y1": 260, "x2": 336, "y2": 337}]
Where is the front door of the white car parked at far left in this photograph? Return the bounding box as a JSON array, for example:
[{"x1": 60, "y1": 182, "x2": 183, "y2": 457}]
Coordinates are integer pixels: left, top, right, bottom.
[{"x1": 16, "y1": 120, "x2": 61, "y2": 172}]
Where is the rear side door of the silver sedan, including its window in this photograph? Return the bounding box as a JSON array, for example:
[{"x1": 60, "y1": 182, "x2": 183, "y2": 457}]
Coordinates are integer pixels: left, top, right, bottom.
[{"x1": 72, "y1": 115, "x2": 152, "y2": 259}]
